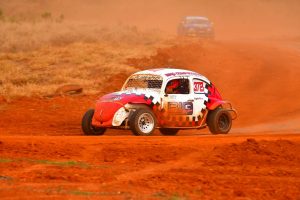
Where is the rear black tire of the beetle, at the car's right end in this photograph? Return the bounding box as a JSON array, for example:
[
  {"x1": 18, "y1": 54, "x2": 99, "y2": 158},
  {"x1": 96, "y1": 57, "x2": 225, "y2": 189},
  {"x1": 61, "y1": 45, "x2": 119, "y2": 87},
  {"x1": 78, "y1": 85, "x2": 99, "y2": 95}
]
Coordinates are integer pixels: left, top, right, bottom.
[{"x1": 206, "y1": 107, "x2": 232, "y2": 134}]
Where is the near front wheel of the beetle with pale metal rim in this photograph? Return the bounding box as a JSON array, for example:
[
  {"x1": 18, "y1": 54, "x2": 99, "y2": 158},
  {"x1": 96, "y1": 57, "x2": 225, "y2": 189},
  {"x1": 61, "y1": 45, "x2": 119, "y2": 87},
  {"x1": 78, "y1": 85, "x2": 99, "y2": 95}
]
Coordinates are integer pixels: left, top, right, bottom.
[{"x1": 129, "y1": 108, "x2": 157, "y2": 136}]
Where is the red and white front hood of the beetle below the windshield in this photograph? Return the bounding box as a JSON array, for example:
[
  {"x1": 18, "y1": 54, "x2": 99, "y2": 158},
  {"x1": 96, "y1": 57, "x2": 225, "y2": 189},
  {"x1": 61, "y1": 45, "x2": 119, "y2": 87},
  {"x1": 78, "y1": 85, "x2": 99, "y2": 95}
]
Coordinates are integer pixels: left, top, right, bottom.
[{"x1": 98, "y1": 89, "x2": 161, "y2": 105}]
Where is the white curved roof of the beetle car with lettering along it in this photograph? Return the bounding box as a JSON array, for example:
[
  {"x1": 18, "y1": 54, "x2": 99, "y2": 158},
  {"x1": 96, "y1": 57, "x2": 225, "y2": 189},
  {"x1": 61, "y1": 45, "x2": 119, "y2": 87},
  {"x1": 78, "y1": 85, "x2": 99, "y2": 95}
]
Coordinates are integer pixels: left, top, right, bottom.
[{"x1": 133, "y1": 68, "x2": 210, "y2": 83}]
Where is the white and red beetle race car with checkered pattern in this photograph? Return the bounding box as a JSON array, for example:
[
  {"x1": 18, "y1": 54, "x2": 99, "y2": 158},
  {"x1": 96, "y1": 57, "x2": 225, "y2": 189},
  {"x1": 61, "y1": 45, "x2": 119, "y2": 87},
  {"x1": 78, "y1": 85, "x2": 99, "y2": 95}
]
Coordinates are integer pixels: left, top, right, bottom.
[{"x1": 82, "y1": 68, "x2": 237, "y2": 136}]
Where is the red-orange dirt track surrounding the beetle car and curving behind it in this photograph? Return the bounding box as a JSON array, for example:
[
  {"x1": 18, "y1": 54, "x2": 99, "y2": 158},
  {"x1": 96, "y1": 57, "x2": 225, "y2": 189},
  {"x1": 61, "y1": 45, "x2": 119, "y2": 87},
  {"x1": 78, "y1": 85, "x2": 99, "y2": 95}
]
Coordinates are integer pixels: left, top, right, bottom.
[{"x1": 0, "y1": 41, "x2": 300, "y2": 199}]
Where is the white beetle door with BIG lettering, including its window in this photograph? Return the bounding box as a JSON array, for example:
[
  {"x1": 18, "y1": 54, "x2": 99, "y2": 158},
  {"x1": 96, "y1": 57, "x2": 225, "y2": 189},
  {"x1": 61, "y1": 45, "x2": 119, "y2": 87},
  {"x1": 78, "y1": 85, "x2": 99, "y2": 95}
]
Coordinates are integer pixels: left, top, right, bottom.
[{"x1": 159, "y1": 77, "x2": 194, "y2": 128}]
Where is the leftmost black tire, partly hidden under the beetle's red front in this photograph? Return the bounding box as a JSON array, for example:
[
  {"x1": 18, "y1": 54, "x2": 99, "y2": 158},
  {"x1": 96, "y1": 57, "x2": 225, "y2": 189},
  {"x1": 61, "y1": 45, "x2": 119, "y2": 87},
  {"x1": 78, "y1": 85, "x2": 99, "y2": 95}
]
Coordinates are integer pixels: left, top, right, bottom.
[{"x1": 81, "y1": 109, "x2": 106, "y2": 135}]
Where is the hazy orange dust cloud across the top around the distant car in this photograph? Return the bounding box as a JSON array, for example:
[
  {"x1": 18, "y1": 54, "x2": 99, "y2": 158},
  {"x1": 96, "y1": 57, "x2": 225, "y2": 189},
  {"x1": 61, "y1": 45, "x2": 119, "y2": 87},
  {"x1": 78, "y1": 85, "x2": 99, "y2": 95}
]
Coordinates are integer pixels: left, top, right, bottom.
[{"x1": 0, "y1": 0, "x2": 300, "y2": 39}]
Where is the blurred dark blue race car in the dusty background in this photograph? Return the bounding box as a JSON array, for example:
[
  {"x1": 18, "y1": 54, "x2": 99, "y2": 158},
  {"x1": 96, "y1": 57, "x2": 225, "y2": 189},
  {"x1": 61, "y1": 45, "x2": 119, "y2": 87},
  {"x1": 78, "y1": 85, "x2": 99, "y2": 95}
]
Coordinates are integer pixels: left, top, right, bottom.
[{"x1": 178, "y1": 16, "x2": 214, "y2": 39}]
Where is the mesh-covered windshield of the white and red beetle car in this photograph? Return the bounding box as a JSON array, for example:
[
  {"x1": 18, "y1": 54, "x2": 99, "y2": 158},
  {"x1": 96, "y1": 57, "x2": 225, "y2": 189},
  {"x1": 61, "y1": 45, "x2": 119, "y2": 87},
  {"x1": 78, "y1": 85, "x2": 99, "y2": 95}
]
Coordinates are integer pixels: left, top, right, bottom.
[{"x1": 123, "y1": 74, "x2": 163, "y2": 90}]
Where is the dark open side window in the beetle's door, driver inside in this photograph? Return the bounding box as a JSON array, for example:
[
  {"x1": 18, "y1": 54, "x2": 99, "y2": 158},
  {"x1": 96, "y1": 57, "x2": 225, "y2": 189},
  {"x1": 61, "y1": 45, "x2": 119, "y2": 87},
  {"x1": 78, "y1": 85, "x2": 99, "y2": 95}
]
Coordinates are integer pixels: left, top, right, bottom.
[{"x1": 165, "y1": 78, "x2": 190, "y2": 94}]
